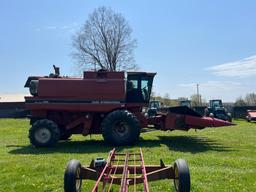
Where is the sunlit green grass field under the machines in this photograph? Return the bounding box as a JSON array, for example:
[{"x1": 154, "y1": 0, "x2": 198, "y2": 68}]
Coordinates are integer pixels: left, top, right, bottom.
[{"x1": 0, "y1": 119, "x2": 256, "y2": 192}]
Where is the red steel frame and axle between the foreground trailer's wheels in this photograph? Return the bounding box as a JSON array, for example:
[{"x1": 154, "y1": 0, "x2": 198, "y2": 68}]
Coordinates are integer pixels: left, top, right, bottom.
[{"x1": 80, "y1": 149, "x2": 175, "y2": 192}]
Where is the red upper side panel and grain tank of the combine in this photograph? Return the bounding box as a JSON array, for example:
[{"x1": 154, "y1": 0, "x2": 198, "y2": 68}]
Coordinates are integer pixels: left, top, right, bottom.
[{"x1": 38, "y1": 71, "x2": 125, "y2": 102}]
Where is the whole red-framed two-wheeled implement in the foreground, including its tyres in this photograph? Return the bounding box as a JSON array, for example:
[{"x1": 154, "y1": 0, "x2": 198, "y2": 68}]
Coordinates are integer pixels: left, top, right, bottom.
[{"x1": 64, "y1": 149, "x2": 190, "y2": 192}]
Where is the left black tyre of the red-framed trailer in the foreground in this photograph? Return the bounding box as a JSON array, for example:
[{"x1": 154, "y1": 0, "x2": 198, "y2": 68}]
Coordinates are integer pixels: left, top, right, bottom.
[{"x1": 64, "y1": 159, "x2": 82, "y2": 192}]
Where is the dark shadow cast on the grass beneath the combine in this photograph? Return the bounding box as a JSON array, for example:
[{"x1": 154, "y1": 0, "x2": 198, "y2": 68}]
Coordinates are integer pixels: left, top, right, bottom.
[{"x1": 7, "y1": 136, "x2": 233, "y2": 155}]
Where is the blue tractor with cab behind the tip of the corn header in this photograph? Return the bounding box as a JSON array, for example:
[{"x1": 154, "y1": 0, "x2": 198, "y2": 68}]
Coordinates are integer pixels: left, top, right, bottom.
[{"x1": 205, "y1": 99, "x2": 232, "y2": 122}]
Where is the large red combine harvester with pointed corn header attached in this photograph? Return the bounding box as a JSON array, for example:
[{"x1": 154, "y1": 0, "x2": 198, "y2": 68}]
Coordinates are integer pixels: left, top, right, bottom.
[{"x1": 25, "y1": 67, "x2": 232, "y2": 147}]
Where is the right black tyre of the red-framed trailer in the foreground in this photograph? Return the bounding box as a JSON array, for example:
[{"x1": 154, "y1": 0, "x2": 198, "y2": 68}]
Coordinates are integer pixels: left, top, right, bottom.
[{"x1": 174, "y1": 159, "x2": 190, "y2": 192}]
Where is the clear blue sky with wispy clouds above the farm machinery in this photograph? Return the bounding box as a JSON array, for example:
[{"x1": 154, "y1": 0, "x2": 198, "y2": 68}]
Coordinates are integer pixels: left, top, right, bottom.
[{"x1": 0, "y1": 0, "x2": 256, "y2": 101}]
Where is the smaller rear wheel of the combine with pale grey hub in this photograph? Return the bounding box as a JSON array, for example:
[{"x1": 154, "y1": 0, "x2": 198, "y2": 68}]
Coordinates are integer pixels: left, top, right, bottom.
[{"x1": 29, "y1": 119, "x2": 60, "y2": 147}]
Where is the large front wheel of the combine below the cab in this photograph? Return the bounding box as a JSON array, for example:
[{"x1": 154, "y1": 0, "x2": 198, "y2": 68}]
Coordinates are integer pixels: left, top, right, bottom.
[{"x1": 101, "y1": 110, "x2": 141, "y2": 145}]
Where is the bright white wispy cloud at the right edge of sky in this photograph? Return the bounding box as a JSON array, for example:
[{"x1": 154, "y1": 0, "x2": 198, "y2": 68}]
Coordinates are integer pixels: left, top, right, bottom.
[{"x1": 207, "y1": 55, "x2": 256, "y2": 77}]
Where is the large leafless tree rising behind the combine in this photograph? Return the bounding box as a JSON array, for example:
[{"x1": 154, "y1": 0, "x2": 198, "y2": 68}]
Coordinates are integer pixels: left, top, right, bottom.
[{"x1": 73, "y1": 7, "x2": 136, "y2": 71}]
